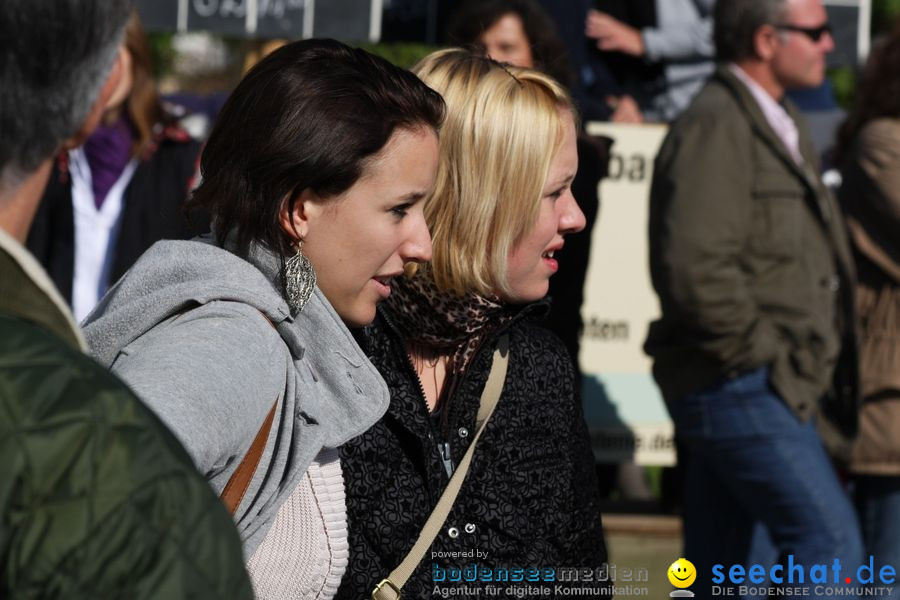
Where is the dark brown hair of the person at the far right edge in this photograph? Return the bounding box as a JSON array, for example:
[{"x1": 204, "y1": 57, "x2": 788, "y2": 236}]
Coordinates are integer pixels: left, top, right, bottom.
[{"x1": 835, "y1": 21, "x2": 900, "y2": 162}]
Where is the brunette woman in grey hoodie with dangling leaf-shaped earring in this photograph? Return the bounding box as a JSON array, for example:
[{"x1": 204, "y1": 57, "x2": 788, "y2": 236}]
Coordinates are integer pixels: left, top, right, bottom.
[{"x1": 86, "y1": 40, "x2": 444, "y2": 599}]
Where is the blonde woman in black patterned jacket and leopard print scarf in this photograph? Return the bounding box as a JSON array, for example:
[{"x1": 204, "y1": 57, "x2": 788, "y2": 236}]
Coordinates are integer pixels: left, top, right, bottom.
[{"x1": 337, "y1": 49, "x2": 606, "y2": 600}]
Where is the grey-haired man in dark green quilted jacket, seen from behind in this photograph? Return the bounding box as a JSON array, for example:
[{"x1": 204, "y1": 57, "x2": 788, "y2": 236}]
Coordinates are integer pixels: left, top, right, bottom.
[{"x1": 0, "y1": 0, "x2": 252, "y2": 598}]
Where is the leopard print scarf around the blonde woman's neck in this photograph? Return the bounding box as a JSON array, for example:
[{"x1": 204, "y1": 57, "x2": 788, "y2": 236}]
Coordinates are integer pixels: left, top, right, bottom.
[{"x1": 386, "y1": 267, "x2": 515, "y2": 384}]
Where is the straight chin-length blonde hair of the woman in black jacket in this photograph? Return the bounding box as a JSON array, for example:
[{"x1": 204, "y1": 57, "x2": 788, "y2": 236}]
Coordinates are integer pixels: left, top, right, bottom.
[{"x1": 412, "y1": 48, "x2": 575, "y2": 296}]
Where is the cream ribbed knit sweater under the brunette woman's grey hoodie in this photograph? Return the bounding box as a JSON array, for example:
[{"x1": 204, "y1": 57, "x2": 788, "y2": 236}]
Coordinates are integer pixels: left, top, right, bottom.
[{"x1": 247, "y1": 448, "x2": 349, "y2": 600}]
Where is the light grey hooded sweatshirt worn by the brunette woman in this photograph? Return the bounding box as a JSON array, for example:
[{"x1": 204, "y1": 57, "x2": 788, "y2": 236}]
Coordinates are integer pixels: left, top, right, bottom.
[{"x1": 84, "y1": 237, "x2": 389, "y2": 557}]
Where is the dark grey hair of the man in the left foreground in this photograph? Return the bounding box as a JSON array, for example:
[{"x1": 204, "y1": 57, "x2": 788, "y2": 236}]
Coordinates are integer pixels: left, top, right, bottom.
[{"x1": 0, "y1": 0, "x2": 131, "y2": 191}]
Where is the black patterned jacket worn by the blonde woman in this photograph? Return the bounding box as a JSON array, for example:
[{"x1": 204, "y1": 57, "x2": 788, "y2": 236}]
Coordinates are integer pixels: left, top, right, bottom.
[{"x1": 337, "y1": 305, "x2": 606, "y2": 600}]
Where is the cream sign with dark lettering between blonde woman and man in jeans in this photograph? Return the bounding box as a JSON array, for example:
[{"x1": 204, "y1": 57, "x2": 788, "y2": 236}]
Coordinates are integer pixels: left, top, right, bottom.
[{"x1": 579, "y1": 123, "x2": 675, "y2": 465}]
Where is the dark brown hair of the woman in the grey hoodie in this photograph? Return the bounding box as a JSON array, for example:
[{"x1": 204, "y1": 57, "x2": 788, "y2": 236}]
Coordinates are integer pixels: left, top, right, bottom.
[{"x1": 190, "y1": 40, "x2": 444, "y2": 254}]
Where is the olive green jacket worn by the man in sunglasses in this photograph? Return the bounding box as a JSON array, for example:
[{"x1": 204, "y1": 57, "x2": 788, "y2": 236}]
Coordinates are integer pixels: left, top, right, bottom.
[{"x1": 645, "y1": 66, "x2": 858, "y2": 452}]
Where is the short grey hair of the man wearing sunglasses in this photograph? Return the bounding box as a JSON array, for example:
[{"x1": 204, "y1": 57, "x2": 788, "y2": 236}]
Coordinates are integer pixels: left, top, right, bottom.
[{"x1": 713, "y1": 0, "x2": 787, "y2": 62}]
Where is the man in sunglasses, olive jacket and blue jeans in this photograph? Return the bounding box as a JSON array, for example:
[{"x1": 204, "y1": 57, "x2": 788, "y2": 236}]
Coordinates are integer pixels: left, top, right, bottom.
[{"x1": 646, "y1": 0, "x2": 862, "y2": 597}]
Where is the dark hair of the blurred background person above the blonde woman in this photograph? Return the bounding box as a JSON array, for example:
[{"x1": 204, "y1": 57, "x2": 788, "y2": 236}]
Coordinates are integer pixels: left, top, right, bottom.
[{"x1": 447, "y1": 0, "x2": 573, "y2": 87}]
